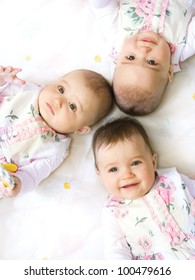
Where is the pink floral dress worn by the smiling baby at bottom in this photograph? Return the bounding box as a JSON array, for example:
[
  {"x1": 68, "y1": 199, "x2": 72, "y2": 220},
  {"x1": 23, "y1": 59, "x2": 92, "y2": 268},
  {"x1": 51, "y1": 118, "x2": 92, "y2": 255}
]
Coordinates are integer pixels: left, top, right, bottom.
[{"x1": 105, "y1": 169, "x2": 195, "y2": 260}]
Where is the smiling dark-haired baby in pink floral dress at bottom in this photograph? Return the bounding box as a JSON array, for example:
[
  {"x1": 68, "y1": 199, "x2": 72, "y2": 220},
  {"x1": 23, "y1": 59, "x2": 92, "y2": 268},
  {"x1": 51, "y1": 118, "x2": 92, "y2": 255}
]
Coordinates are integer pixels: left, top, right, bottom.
[{"x1": 93, "y1": 118, "x2": 195, "y2": 260}]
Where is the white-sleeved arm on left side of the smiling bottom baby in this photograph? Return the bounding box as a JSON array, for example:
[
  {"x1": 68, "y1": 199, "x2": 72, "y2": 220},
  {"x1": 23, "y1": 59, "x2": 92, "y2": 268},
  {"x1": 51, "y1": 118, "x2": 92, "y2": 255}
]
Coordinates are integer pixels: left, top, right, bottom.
[{"x1": 103, "y1": 208, "x2": 132, "y2": 260}]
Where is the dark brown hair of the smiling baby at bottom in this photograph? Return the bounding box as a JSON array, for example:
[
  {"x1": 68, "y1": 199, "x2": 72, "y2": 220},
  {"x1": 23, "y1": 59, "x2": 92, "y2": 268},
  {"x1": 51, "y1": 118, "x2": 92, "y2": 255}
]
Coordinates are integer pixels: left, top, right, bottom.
[{"x1": 92, "y1": 117, "x2": 153, "y2": 168}]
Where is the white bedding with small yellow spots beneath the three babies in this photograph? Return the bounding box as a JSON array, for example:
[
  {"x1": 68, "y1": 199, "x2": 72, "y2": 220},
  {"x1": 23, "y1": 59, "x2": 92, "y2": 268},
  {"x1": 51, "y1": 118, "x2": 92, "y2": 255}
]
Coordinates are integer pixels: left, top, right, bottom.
[{"x1": 0, "y1": 0, "x2": 195, "y2": 260}]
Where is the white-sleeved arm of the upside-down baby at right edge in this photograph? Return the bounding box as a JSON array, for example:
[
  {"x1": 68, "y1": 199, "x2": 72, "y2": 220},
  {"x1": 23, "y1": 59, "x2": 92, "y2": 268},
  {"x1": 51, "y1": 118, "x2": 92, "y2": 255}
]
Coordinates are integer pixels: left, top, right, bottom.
[{"x1": 180, "y1": 16, "x2": 195, "y2": 61}]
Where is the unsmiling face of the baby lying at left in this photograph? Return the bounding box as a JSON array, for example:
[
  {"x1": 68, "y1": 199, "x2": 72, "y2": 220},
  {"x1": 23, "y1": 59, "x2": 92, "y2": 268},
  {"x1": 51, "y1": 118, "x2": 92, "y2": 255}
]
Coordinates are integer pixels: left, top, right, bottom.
[{"x1": 38, "y1": 71, "x2": 97, "y2": 133}]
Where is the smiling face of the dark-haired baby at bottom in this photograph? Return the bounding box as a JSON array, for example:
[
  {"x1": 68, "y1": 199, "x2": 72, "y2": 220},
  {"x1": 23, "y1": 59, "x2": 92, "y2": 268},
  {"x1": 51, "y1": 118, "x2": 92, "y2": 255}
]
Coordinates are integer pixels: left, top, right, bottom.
[{"x1": 96, "y1": 135, "x2": 156, "y2": 200}]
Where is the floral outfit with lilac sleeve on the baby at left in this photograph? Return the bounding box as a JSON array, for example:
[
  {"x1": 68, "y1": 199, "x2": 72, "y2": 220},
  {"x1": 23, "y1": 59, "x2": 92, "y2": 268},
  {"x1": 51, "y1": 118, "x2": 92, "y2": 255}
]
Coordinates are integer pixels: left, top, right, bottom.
[{"x1": 0, "y1": 83, "x2": 71, "y2": 192}]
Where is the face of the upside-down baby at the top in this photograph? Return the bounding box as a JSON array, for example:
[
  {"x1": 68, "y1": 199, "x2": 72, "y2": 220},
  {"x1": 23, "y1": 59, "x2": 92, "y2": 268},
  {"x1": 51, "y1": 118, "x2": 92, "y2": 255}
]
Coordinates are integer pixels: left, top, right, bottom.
[{"x1": 115, "y1": 31, "x2": 172, "y2": 91}]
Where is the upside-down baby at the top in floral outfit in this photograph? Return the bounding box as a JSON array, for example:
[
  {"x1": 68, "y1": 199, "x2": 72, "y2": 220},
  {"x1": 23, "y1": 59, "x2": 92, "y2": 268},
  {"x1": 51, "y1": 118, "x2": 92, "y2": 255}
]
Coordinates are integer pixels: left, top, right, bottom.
[{"x1": 90, "y1": 0, "x2": 195, "y2": 115}]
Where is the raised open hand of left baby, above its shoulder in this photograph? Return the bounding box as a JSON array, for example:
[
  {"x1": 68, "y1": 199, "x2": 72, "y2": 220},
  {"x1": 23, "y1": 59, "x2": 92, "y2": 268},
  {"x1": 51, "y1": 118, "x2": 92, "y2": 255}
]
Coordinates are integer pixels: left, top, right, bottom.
[{"x1": 0, "y1": 65, "x2": 25, "y2": 86}]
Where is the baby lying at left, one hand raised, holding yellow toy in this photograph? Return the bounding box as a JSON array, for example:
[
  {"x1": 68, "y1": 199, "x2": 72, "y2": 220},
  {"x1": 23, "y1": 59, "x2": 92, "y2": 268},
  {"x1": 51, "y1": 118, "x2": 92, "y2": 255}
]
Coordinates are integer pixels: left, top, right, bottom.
[{"x1": 0, "y1": 66, "x2": 112, "y2": 197}]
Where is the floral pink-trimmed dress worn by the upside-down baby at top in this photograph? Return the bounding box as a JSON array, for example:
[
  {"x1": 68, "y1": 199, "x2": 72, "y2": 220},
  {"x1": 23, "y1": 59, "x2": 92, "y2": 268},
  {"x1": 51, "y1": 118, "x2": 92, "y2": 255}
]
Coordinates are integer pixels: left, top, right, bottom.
[{"x1": 113, "y1": 0, "x2": 192, "y2": 72}]
